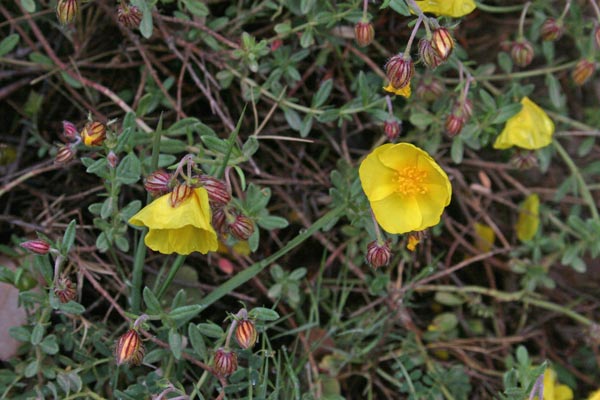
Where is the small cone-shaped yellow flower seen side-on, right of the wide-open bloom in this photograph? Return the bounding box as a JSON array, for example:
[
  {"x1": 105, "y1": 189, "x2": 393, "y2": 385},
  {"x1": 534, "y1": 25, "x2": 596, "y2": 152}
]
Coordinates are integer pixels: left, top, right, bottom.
[{"x1": 494, "y1": 97, "x2": 554, "y2": 150}]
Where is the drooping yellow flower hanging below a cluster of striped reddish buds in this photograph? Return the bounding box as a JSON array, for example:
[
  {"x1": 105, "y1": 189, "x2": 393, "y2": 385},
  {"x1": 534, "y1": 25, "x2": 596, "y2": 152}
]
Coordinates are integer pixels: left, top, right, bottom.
[{"x1": 129, "y1": 188, "x2": 219, "y2": 254}]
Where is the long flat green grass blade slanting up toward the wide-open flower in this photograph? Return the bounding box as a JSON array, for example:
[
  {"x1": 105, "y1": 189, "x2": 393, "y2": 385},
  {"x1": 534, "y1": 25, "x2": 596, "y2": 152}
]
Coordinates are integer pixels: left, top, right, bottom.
[{"x1": 199, "y1": 205, "x2": 347, "y2": 308}]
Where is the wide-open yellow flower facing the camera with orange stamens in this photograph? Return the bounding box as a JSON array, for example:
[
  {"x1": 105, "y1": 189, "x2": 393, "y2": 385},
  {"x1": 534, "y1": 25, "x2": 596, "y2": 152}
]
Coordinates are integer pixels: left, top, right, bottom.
[{"x1": 358, "y1": 143, "x2": 452, "y2": 233}]
